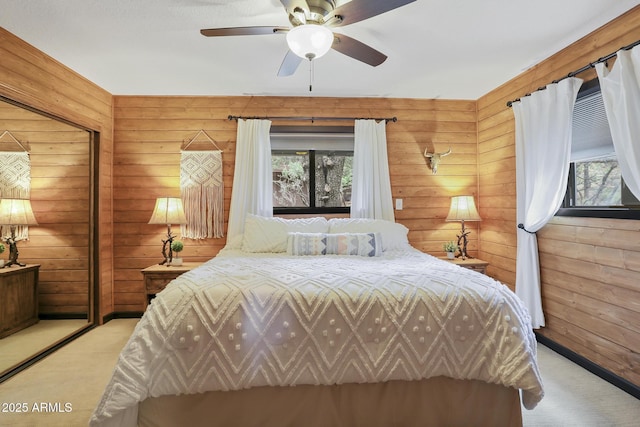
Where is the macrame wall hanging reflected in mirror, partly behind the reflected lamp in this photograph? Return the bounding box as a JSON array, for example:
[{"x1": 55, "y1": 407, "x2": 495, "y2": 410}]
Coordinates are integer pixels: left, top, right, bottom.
[{"x1": 0, "y1": 130, "x2": 31, "y2": 240}]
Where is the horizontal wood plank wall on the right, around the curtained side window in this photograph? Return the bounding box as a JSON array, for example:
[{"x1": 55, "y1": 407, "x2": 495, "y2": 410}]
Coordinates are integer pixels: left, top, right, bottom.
[{"x1": 478, "y1": 7, "x2": 640, "y2": 385}]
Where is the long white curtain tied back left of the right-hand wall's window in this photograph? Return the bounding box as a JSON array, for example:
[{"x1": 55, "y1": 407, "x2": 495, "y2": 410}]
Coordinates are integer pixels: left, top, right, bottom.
[{"x1": 513, "y1": 77, "x2": 582, "y2": 329}]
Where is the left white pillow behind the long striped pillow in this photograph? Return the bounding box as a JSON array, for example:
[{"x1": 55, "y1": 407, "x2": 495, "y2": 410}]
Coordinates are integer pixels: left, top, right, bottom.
[{"x1": 242, "y1": 214, "x2": 329, "y2": 253}]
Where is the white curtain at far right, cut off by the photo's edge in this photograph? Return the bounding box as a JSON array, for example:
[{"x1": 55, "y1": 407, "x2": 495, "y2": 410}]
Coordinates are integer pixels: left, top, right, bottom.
[{"x1": 596, "y1": 46, "x2": 640, "y2": 199}]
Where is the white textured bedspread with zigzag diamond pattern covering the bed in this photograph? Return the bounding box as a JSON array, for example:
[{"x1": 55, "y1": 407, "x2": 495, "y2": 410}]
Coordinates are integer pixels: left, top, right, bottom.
[{"x1": 91, "y1": 249, "x2": 543, "y2": 426}]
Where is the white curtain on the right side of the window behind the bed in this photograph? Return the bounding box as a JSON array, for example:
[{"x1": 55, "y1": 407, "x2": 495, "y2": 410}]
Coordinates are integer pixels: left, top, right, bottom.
[{"x1": 351, "y1": 120, "x2": 395, "y2": 221}]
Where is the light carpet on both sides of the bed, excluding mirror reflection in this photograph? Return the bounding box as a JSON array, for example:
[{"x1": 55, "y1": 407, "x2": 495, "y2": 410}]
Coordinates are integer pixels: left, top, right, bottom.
[{"x1": 0, "y1": 319, "x2": 640, "y2": 427}]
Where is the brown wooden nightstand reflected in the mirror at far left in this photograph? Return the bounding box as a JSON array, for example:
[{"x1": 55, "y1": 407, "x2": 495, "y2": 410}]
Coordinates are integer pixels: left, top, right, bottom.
[{"x1": 0, "y1": 264, "x2": 40, "y2": 338}]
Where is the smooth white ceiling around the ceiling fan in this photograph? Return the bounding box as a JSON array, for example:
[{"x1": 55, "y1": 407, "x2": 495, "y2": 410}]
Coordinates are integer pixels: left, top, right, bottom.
[{"x1": 0, "y1": 0, "x2": 640, "y2": 99}]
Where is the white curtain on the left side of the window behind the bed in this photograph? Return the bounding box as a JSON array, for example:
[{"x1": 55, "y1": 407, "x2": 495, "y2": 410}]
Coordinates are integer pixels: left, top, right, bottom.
[{"x1": 227, "y1": 119, "x2": 273, "y2": 247}]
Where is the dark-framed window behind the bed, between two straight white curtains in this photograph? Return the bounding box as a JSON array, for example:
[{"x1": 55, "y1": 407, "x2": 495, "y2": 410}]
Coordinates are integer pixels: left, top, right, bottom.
[{"x1": 271, "y1": 127, "x2": 353, "y2": 214}]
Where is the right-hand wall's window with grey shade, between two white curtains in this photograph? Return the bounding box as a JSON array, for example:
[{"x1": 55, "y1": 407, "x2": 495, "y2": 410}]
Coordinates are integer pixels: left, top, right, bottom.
[{"x1": 558, "y1": 79, "x2": 640, "y2": 219}]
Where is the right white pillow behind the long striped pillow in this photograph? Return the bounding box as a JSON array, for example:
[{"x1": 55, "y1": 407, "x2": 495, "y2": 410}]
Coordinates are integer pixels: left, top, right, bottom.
[{"x1": 329, "y1": 218, "x2": 409, "y2": 251}]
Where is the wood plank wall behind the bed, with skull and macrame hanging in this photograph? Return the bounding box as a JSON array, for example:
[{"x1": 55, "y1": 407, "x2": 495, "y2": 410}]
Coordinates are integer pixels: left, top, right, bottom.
[{"x1": 114, "y1": 96, "x2": 478, "y2": 312}]
